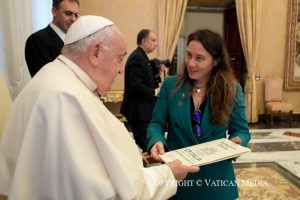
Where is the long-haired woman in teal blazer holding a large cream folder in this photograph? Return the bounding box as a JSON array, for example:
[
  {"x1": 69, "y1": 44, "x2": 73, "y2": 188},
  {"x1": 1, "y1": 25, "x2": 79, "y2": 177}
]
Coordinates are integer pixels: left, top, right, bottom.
[{"x1": 147, "y1": 30, "x2": 250, "y2": 200}]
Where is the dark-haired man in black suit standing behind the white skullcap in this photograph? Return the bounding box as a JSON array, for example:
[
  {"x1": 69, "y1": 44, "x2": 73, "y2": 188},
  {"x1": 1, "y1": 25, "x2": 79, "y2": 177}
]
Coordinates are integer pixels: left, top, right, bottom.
[{"x1": 25, "y1": 0, "x2": 79, "y2": 77}]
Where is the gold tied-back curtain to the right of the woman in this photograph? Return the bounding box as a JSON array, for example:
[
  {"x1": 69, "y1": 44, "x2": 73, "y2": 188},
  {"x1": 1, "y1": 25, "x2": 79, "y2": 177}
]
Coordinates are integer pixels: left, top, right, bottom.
[{"x1": 235, "y1": 0, "x2": 262, "y2": 123}]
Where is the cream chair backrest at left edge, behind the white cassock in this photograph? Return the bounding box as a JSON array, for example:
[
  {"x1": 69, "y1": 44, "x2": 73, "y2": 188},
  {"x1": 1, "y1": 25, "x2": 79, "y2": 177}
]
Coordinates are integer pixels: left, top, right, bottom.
[{"x1": 0, "y1": 72, "x2": 12, "y2": 139}]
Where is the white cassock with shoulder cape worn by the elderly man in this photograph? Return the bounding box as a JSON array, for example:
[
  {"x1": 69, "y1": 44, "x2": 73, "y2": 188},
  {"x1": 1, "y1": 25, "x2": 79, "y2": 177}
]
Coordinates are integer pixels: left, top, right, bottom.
[{"x1": 0, "y1": 55, "x2": 177, "y2": 200}]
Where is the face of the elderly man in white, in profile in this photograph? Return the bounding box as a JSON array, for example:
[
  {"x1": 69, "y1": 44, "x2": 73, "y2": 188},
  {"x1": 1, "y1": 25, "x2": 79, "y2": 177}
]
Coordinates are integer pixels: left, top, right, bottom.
[{"x1": 97, "y1": 27, "x2": 127, "y2": 95}]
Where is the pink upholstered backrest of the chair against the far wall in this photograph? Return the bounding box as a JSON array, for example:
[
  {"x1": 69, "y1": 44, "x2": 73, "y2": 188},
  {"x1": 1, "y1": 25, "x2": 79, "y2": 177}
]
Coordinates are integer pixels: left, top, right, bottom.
[{"x1": 264, "y1": 76, "x2": 283, "y2": 102}]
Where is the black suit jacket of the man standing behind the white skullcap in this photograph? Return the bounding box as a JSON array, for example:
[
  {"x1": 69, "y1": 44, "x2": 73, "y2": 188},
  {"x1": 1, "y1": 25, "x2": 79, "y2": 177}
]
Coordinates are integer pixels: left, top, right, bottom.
[{"x1": 25, "y1": 25, "x2": 64, "y2": 77}]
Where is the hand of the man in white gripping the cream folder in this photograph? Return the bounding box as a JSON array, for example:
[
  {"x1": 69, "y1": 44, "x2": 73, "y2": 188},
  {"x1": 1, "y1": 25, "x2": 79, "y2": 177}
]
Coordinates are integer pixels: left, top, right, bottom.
[{"x1": 166, "y1": 160, "x2": 200, "y2": 181}]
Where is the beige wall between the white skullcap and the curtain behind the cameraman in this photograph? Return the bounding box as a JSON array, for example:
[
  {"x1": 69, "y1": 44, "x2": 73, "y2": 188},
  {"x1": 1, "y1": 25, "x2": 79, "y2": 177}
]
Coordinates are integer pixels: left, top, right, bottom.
[{"x1": 80, "y1": 0, "x2": 158, "y2": 90}]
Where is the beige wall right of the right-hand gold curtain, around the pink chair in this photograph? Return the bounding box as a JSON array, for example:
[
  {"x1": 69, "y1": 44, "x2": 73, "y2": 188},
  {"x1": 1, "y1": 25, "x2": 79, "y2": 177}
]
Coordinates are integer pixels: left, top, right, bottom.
[{"x1": 256, "y1": 0, "x2": 300, "y2": 114}]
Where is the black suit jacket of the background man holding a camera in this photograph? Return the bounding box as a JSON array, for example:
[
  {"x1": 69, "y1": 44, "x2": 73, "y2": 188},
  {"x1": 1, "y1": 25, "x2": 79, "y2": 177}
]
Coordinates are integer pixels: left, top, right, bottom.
[{"x1": 121, "y1": 47, "x2": 156, "y2": 122}]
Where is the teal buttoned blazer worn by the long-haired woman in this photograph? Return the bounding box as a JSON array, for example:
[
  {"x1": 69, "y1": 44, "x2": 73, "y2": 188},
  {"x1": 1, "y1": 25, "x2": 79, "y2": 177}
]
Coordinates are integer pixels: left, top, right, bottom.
[{"x1": 147, "y1": 76, "x2": 250, "y2": 200}]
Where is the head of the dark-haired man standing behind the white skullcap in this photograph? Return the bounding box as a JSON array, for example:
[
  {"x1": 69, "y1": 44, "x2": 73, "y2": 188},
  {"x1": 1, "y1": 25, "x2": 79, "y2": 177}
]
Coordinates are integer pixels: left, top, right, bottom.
[{"x1": 52, "y1": 0, "x2": 79, "y2": 33}]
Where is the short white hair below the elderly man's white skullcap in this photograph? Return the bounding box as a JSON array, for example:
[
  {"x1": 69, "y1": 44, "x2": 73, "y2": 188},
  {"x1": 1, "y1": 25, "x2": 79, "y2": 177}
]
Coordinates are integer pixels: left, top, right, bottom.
[{"x1": 61, "y1": 26, "x2": 113, "y2": 56}]
